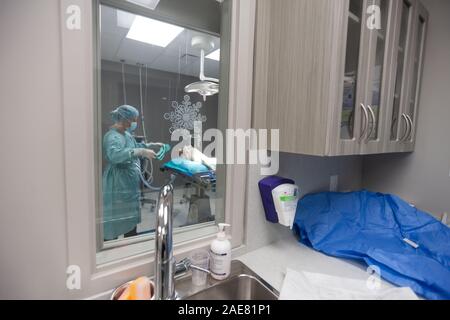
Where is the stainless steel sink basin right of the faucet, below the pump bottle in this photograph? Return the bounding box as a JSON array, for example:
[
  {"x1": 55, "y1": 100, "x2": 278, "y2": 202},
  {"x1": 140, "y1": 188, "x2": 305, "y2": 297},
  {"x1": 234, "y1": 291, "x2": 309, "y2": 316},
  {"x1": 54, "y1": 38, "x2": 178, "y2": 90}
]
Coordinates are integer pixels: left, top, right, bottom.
[{"x1": 175, "y1": 260, "x2": 279, "y2": 300}]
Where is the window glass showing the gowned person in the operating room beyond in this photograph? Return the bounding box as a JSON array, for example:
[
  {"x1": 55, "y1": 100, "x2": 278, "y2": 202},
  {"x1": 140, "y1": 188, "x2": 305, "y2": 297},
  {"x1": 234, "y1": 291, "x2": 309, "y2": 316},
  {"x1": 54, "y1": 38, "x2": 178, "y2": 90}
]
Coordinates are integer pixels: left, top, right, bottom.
[{"x1": 97, "y1": 3, "x2": 227, "y2": 254}]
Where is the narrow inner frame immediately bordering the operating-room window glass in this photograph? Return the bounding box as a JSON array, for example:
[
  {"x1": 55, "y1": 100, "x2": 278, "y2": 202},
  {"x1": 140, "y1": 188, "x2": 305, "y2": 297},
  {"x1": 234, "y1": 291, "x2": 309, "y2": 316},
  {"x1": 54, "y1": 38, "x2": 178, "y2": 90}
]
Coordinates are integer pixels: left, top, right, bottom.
[{"x1": 93, "y1": 0, "x2": 227, "y2": 268}]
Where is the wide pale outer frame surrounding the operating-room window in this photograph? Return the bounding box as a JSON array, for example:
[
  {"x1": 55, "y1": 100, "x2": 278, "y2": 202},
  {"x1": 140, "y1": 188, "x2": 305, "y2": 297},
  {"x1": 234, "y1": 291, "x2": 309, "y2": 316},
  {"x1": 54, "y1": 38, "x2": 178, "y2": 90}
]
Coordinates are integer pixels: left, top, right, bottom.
[{"x1": 60, "y1": 0, "x2": 256, "y2": 298}]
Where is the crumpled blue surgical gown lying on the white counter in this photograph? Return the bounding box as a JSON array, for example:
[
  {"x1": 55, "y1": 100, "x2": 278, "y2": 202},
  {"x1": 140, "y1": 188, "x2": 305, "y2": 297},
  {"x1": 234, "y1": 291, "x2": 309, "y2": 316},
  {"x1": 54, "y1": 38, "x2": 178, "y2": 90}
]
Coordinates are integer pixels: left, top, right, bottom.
[{"x1": 294, "y1": 191, "x2": 450, "y2": 299}]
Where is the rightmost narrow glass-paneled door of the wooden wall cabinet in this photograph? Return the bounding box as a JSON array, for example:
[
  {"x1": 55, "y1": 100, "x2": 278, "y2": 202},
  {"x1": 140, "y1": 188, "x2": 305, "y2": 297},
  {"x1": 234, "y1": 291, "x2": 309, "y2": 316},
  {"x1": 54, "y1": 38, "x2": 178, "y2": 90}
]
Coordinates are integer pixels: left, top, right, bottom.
[{"x1": 402, "y1": 2, "x2": 428, "y2": 151}]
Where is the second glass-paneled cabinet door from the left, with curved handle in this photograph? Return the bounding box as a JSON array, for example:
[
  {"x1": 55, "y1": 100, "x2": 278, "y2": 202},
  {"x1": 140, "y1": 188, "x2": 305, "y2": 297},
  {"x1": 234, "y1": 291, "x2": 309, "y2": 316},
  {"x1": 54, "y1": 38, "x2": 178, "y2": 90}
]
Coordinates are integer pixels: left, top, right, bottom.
[{"x1": 361, "y1": 0, "x2": 396, "y2": 154}]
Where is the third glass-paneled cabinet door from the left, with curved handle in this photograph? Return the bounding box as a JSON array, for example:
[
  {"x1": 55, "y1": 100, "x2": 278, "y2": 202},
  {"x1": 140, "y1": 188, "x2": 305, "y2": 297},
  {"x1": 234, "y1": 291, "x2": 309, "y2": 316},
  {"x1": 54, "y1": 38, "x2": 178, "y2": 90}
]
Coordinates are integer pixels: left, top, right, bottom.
[{"x1": 385, "y1": 0, "x2": 414, "y2": 152}]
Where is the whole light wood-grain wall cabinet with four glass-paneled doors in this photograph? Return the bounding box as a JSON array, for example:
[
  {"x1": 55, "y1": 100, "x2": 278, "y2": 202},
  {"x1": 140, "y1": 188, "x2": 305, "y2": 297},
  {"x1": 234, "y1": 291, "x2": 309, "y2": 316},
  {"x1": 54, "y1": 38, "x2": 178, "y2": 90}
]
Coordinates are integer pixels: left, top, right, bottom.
[{"x1": 253, "y1": 0, "x2": 427, "y2": 156}]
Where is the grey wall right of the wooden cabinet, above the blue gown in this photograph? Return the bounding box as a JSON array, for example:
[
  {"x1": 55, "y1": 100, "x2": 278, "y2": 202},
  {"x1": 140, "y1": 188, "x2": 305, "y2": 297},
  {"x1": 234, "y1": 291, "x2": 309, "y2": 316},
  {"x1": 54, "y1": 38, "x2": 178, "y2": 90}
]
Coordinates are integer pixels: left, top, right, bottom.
[{"x1": 363, "y1": 0, "x2": 450, "y2": 217}]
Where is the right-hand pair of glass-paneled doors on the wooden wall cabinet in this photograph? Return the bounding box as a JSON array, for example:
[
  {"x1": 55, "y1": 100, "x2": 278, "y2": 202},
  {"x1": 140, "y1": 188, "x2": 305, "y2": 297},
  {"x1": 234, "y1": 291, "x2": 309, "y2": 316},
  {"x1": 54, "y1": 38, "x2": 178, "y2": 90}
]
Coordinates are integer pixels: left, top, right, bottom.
[{"x1": 384, "y1": 0, "x2": 428, "y2": 152}]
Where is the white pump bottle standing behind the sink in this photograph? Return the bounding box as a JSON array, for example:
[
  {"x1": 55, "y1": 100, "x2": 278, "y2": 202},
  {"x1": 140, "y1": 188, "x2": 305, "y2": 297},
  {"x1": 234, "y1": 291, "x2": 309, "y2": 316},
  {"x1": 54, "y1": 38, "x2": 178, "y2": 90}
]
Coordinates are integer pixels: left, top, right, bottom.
[{"x1": 211, "y1": 223, "x2": 231, "y2": 280}]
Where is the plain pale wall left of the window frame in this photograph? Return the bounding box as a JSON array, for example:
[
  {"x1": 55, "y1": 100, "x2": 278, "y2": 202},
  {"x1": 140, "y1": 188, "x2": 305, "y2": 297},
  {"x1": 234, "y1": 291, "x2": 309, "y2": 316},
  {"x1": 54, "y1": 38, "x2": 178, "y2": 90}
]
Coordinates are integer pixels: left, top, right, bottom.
[{"x1": 0, "y1": 0, "x2": 67, "y2": 299}]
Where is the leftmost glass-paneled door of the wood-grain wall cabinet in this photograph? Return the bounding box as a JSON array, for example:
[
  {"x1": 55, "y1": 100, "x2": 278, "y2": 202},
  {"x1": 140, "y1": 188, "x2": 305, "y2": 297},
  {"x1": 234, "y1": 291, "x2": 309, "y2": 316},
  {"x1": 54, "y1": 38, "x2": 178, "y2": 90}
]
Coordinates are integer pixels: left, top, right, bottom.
[{"x1": 328, "y1": 0, "x2": 372, "y2": 156}]
